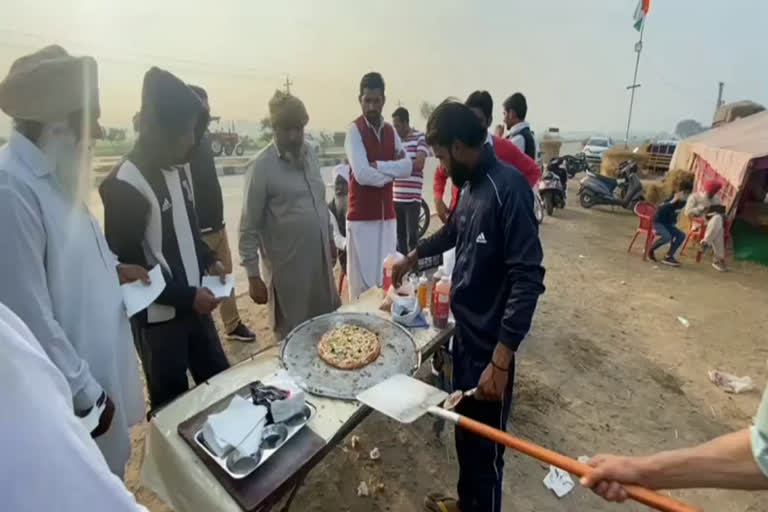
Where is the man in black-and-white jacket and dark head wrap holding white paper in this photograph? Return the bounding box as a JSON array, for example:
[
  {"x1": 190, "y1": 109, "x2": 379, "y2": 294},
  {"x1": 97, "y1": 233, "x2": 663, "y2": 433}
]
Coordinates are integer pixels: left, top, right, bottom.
[{"x1": 99, "y1": 68, "x2": 229, "y2": 408}]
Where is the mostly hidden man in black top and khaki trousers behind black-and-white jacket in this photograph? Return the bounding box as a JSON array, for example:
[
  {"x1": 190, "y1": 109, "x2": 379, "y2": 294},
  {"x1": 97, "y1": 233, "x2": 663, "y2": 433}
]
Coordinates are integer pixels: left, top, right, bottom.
[{"x1": 189, "y1": 85, "x2": 256, "y2": 341}]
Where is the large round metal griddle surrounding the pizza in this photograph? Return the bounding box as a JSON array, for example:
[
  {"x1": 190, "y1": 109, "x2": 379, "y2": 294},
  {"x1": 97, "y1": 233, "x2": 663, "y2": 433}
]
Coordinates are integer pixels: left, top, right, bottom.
[{"x1": 280, "y1": 312, "x2": 421, "y2": 400}]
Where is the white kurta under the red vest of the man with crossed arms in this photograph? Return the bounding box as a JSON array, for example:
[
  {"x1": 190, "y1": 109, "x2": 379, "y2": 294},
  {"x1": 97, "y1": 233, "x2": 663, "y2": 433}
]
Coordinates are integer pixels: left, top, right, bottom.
[{"x1": 344, "y1": 119, "x2": 413, "y2": 301}]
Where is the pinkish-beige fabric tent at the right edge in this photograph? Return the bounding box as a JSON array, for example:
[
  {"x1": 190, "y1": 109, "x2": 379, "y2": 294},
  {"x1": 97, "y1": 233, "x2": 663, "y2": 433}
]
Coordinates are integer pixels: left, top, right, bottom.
[{"x1": 670, "y1": 111, "x2": 768, "y2": 265}]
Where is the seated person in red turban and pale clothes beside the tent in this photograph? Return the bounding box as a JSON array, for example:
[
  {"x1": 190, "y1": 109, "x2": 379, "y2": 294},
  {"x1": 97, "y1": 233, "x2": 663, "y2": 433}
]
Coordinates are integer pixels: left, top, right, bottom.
[{"x1": 685, "y1": 181, "x2": 727, "y2": 272}]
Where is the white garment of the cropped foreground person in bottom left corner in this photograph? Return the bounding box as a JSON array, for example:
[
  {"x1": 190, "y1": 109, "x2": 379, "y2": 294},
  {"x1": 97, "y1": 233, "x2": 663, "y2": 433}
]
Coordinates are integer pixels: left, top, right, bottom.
[{"x1": 0, "y1": 304, "x2": 146, "y2": 512}]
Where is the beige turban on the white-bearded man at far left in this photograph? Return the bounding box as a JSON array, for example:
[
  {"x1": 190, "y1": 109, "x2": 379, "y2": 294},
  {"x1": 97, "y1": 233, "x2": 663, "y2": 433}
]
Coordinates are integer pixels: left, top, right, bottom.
[{"x1": 0, "y1": 45, "x2": 99, "y2": 123}]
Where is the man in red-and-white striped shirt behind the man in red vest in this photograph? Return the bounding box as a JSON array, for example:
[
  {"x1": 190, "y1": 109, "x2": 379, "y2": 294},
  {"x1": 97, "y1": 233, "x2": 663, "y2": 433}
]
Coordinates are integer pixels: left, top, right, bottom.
[{"x1": 392, "y1": 107, "x2": 429, "y2": 254}]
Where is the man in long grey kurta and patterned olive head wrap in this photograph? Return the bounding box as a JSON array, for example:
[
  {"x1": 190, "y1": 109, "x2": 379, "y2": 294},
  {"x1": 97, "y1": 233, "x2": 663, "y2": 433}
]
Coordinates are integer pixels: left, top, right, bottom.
[{"x1": 240, "y1": 91, "x2": 340, "y2": 340}]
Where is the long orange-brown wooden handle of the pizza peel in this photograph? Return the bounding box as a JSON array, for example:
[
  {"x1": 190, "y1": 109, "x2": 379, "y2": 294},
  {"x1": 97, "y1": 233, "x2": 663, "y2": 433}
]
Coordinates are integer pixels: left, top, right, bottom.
[{"x1": 457, "y1": 415, "x2": 702, "y2": 512}]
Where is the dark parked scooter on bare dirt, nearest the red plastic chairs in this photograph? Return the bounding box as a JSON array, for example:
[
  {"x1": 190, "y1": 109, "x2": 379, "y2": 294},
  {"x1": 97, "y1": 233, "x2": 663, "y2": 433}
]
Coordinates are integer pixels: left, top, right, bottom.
[{"x1": 579, "y1": 160, "x2": 645, "y2": 210}]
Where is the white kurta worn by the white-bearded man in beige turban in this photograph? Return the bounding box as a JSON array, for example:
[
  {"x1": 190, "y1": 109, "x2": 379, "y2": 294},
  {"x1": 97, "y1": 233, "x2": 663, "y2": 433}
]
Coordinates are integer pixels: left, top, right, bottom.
[{"x1": 0, "y1": 132, "x2": 144, "y2": 475}]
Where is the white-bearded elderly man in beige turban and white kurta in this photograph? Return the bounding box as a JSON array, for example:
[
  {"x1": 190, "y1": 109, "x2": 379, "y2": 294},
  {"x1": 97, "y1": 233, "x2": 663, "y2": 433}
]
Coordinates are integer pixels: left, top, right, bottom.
[{"x1": 0, "y1": 46, "x2": 148, "y2": 476}]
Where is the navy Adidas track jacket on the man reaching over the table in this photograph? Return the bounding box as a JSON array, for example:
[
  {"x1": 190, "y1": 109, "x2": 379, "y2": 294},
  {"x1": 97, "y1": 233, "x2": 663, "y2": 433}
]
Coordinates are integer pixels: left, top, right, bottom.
[{"x1": 417, "y1": 146, "x2": 544, "y2": 354}]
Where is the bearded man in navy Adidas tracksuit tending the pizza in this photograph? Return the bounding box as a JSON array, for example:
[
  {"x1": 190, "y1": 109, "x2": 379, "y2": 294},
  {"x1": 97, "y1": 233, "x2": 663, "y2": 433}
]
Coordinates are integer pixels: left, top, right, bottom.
[{"x1": 393, "y1": 103, "x2": 544, "y2": 512}]
